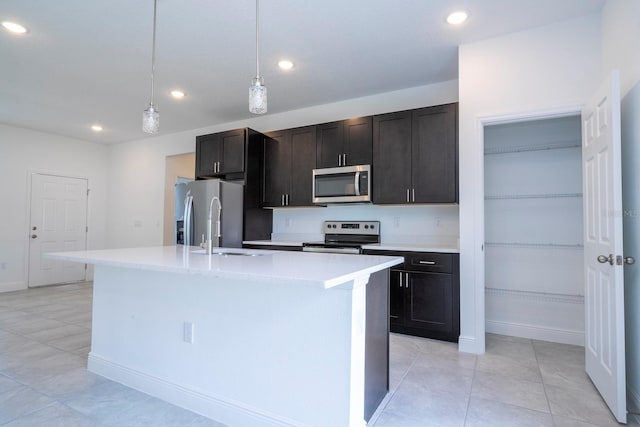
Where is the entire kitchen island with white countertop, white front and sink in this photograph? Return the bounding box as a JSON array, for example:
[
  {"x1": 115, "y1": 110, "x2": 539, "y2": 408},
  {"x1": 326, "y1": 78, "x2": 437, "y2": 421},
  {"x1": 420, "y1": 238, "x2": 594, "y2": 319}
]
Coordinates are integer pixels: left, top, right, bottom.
[{"x1": 50, "y1": 246, "x2": 403, "y2": 426}]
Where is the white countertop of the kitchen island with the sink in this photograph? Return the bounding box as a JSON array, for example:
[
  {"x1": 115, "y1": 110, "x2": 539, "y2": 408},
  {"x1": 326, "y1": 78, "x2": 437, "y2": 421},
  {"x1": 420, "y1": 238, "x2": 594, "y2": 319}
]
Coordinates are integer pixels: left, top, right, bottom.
[{"x1": 47, "y1": 246, "x2": 403, "y2": 288}]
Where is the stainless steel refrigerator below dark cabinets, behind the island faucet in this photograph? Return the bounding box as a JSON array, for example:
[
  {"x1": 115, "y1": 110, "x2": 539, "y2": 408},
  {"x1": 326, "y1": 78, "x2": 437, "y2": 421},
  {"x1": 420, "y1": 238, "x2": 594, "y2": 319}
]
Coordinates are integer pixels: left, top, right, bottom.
[{"x1": 174, "y1": 179, "x2": 244, "y2": 248}]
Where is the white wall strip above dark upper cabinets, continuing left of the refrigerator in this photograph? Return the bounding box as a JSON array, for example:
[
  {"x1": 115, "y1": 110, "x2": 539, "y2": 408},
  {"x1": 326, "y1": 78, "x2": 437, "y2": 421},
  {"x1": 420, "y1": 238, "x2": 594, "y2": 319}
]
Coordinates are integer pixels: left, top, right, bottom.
[{"x1": 108, "y1": 81, "x2": 458, "y2": 247}]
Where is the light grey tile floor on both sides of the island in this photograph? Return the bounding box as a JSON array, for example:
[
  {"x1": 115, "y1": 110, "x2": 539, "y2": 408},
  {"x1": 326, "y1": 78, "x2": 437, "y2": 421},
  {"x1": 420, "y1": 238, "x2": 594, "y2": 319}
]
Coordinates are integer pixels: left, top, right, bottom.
[{"x1": 0, "y1": 283, "x2": 637, "y2": 427}]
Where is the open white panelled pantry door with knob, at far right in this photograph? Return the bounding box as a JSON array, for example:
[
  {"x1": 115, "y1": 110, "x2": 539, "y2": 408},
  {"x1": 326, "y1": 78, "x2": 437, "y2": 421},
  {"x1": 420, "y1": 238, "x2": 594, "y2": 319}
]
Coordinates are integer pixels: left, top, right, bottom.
[{"x1": 582, "y1": 72, "x2": 627, "y2": 423}]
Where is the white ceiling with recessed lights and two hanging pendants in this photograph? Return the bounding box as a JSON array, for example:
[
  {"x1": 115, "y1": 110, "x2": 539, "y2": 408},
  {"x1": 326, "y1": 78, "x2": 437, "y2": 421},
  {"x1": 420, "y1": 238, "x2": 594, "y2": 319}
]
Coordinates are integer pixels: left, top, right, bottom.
[{"x1": 0, "y1": 0, "x2": 605, "y2": 143}]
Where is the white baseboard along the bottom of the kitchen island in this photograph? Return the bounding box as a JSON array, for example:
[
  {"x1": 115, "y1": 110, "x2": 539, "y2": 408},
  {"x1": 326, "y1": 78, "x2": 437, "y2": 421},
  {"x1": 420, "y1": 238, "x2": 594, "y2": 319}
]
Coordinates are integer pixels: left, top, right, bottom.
[{"x1": 87, "y1": 353, "x2": 301, "y2": 427}]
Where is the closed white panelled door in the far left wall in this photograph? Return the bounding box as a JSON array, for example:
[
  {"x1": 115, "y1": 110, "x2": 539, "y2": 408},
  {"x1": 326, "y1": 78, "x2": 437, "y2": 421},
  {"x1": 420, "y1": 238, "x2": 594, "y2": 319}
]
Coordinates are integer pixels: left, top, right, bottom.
[{"x1": 29, "y1": 174, "x2": 88, "y2": 287}]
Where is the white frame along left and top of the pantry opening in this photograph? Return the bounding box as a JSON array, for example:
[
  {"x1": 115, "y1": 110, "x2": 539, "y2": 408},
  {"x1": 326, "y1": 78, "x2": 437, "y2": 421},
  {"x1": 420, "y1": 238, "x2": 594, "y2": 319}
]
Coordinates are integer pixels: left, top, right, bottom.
[{"x1": 459, "y1": 105, "x2": 582, "y2": 354}]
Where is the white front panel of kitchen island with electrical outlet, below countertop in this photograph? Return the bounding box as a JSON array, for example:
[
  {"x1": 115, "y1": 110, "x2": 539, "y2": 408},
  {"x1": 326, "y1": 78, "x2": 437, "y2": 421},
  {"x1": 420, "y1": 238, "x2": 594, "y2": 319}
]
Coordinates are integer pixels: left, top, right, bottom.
[{"x1": 89, "y1": 265, "x2": 378, "y2": 426}]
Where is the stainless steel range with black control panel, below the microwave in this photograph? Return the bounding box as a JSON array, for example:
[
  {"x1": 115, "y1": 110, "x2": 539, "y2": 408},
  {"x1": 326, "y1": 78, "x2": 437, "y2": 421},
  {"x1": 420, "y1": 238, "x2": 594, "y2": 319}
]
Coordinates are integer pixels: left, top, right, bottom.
[{"x1": 302, "y1": 221, "x2": 380, "y2": 254}]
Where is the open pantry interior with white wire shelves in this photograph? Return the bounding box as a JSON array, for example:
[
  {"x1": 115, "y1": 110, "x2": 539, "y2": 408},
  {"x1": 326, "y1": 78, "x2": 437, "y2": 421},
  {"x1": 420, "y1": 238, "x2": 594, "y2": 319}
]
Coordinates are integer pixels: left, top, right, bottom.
[{"x1": 484, "y1": 115, "x2": 585, "y2": 345}]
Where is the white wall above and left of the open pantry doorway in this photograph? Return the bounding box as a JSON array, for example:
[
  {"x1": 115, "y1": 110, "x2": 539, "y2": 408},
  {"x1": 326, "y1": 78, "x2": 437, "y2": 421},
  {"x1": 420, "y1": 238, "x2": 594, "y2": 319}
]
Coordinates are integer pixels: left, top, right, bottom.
[{"x1": 459, "y1": 15, "x2": 601, "y2": 353}]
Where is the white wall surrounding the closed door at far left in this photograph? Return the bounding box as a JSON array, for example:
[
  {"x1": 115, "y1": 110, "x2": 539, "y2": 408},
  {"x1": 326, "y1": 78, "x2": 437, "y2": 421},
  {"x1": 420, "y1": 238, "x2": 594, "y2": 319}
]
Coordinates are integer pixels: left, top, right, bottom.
[{"x1": 0, "y1": 125, "x2": 108, "y2": 292}]
